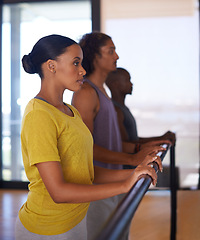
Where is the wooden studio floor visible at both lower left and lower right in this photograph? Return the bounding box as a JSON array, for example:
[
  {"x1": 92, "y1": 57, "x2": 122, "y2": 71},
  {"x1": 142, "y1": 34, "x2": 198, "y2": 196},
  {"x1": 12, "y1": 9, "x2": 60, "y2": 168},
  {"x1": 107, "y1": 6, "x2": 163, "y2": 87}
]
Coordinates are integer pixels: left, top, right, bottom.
[{"x1": 0, "y1": 190, "x2": 200, "y2": 240}]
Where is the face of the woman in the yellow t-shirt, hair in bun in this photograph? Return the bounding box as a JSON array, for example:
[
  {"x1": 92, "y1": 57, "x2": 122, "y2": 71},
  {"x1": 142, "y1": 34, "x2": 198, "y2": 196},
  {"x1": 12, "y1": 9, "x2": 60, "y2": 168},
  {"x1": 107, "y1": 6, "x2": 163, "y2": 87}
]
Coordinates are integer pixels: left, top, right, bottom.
[{"x1": 56, "y1": 44, "x2": 86, "y2": 91}]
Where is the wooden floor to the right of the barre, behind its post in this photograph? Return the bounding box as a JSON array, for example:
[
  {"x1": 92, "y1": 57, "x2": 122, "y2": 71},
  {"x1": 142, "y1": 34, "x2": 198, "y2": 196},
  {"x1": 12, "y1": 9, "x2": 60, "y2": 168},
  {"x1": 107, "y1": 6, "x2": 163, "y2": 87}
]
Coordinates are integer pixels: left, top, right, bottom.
[{"x1": 130, "y1": 191, "x2": 200, "y2": 240}]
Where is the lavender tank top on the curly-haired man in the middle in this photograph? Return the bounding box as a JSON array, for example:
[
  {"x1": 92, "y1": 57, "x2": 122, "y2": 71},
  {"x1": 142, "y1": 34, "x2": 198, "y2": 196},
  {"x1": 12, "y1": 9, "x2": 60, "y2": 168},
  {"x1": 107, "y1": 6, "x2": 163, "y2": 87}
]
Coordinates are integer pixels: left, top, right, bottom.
[{"x1": 85, "y1": 79, "x2": 122, "y2": 169}]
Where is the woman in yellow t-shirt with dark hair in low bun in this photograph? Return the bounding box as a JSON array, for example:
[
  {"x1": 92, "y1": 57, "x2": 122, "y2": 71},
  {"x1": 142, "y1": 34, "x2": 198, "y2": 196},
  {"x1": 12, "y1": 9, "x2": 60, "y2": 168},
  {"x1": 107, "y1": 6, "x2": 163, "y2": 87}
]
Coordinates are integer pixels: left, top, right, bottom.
[{"x1": 15, "y1": 35, "x2": 163, "y2": 240}]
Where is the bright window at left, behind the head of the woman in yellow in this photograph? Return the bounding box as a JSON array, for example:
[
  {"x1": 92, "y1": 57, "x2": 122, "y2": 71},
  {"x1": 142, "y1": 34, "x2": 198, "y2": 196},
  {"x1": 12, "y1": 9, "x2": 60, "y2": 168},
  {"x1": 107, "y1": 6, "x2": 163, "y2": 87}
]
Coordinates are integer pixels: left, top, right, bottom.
[{"x1": 2, "y1": 1, "x2": 92, "y2": 181}]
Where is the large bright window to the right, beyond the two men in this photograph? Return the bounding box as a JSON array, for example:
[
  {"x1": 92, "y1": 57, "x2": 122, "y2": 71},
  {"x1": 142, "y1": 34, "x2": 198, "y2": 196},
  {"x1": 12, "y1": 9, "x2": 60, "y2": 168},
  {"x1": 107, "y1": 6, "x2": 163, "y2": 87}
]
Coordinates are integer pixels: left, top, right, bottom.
[{"x1": 101, "y1": 0, "x2": 199, "y2": 188}]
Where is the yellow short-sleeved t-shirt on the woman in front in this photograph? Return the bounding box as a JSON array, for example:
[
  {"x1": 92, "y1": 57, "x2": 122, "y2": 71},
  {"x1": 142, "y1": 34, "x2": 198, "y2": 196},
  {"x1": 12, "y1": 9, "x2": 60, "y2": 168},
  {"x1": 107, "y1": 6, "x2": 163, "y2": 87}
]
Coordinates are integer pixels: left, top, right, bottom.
[{"x1": 19, "y1": 99, "x2": 94, "y2": 235}]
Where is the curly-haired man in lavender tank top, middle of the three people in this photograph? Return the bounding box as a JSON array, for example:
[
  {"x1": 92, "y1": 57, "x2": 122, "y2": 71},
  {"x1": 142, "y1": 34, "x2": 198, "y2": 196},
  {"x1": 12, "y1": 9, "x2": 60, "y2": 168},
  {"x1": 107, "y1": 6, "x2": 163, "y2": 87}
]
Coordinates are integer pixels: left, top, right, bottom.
[{"x1": 72, "y1": 32, "x2": 167, "y2": 240}]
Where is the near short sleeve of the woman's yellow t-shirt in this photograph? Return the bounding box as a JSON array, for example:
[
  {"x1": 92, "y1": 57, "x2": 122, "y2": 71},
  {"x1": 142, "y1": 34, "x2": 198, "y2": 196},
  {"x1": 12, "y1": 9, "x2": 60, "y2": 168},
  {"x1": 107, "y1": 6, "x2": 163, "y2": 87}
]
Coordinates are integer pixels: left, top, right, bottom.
[{"x1": 21, "y1": 110, "x2": 60, "y2": 165}]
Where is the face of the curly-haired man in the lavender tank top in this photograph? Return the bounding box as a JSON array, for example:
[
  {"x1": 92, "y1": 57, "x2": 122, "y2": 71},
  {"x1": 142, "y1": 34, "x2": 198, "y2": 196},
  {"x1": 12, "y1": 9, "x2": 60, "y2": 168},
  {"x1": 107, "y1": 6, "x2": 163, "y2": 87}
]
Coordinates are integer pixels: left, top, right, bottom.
[{"x1": 95, "y1": 40, "x2": 119, "y2": 74}]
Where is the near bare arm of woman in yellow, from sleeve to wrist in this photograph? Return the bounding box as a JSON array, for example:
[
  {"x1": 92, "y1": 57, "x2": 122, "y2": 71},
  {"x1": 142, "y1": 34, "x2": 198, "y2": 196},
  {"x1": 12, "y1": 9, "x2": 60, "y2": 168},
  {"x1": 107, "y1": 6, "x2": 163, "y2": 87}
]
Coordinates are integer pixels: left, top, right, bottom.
[{"x1": 36, "y1": 162, "x2": 127, "y2": 203}]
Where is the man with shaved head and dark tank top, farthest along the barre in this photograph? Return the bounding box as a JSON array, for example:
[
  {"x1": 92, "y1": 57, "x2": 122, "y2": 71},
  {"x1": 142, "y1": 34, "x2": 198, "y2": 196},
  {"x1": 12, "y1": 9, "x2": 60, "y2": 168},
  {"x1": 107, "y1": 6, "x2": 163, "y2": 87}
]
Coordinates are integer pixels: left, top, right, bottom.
[{"x1": 106, "y1": 68, "x2": 175, "y2": 144}]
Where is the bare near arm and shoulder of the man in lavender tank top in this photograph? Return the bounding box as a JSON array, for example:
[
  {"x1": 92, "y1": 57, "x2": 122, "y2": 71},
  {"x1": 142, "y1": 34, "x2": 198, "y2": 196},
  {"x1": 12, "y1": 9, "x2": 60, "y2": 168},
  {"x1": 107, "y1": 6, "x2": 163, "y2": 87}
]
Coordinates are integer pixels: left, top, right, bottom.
[{"x1": 72, "y1": 83, "x2": 166, "y2": 166}]
